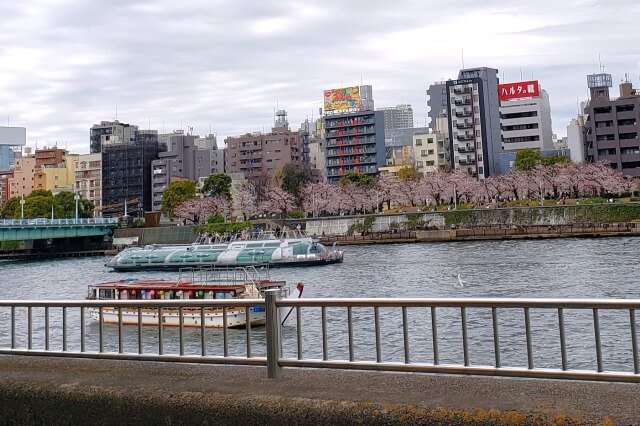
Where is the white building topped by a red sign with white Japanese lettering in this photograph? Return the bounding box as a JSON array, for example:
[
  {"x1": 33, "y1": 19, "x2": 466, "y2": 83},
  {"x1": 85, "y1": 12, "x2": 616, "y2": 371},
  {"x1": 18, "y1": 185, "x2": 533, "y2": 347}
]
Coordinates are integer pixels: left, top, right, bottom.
[{"x1": 500, "y1": 85, "x2": 554, "y2": 151}]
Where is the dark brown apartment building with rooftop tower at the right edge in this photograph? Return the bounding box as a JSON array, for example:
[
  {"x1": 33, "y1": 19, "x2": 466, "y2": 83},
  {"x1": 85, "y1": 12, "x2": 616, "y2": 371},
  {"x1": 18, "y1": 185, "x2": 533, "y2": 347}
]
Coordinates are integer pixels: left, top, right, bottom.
[{"x1": 584, "y1": 73, "x2": 640, "y2": 176}]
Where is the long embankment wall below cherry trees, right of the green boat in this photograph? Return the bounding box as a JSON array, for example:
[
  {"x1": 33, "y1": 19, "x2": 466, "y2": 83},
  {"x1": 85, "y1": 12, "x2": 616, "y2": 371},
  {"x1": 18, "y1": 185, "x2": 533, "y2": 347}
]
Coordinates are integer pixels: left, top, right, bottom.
[{"x1": 306, "y1": 203, "x2": 640, "y2": 235}]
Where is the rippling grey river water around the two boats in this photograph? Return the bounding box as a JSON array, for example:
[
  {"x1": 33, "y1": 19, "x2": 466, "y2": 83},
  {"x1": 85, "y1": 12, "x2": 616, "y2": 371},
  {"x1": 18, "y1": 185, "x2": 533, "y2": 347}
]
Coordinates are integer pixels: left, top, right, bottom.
[{"x1": 0, "y1": 238, "x2": 640, "y2": 371}]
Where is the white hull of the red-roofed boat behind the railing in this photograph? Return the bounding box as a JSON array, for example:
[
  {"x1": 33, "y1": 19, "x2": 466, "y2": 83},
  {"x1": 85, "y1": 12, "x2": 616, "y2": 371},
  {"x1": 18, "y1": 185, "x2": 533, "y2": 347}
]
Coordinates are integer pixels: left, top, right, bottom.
[{"x1": 88, "y1": 306, "x2": 266, "y2": 328}]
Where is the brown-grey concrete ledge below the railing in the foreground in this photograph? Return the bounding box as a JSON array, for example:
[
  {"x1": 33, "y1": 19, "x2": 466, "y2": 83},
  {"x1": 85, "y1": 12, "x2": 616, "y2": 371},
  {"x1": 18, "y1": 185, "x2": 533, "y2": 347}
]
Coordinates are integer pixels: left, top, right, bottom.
[{"x1": 0, "y1": 356, "x2": 640, "y2": 425}]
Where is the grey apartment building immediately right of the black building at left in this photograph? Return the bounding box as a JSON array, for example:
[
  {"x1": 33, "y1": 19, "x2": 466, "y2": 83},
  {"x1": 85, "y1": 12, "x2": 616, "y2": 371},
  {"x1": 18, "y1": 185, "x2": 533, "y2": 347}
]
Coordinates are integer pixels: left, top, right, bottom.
[{"x1": 151, "y1": 132, "x2": 213, "y2": 211}]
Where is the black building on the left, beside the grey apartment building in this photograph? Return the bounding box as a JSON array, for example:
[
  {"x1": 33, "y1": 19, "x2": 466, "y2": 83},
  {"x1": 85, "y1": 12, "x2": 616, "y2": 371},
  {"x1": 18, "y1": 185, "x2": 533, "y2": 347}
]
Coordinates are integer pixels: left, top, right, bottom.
[{"x1": 102, "y1": 130, "x2": 159, "y2": 217}]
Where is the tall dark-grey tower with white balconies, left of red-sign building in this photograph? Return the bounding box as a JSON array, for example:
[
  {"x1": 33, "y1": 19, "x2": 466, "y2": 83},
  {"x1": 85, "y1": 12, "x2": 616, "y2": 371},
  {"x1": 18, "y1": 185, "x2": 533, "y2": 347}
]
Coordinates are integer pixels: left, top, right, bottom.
[{"x1": 446, "y1": 68, "x2": 502, "y2": 179}]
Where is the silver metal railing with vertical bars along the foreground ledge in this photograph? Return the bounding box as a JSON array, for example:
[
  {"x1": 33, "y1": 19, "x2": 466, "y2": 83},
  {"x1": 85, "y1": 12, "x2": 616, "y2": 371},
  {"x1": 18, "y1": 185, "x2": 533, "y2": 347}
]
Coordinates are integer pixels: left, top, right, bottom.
[{"x1": 0, "y1": 291, "x2": 640, "y2": 382}]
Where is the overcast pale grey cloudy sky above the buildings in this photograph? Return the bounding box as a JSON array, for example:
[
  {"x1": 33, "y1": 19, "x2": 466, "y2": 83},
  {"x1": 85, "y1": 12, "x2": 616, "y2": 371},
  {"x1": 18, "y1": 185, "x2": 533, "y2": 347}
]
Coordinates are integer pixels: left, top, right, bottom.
[{"x1": 0, "y1": 0, "x2": 640, "y2": 153}]
